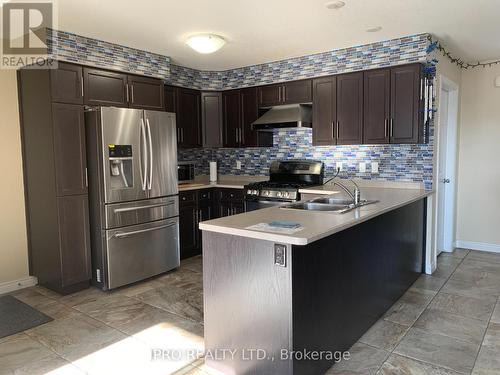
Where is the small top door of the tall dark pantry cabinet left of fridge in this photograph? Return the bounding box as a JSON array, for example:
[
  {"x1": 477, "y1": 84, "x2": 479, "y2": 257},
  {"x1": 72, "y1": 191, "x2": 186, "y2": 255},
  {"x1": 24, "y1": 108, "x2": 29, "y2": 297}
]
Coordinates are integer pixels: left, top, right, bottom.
[{"x1": 50, "y1": 62, "x2": 83, "y2": 104}]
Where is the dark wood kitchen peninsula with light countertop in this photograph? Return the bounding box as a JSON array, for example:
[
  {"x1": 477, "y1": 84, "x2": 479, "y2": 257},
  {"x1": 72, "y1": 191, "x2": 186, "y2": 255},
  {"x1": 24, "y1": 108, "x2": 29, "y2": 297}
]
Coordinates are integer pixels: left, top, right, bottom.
[{"x1": 200, "y1": 188, "x2": 432, "y2": 374}]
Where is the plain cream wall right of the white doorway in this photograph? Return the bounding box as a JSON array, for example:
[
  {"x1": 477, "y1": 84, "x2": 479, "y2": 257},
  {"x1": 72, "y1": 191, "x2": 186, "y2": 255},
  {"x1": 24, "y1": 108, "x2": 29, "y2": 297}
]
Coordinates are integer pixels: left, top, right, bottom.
[{"x1": 456, "y1": 66, "x2": 500, "y2": 251}]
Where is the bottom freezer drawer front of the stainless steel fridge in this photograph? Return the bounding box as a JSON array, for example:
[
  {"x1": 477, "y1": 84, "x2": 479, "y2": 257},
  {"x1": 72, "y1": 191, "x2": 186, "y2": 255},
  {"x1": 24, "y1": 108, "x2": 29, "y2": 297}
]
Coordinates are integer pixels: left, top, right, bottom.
[{"x1": 106, "y1": 217, "x2": 180, "y2": 289}]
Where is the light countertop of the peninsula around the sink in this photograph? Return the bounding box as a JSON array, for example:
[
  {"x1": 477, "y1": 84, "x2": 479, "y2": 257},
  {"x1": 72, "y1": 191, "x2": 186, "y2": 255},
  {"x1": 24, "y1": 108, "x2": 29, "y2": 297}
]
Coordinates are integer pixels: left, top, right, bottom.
[{"x1": 200, "y1": 185, "x2": 433, "y2": 245}]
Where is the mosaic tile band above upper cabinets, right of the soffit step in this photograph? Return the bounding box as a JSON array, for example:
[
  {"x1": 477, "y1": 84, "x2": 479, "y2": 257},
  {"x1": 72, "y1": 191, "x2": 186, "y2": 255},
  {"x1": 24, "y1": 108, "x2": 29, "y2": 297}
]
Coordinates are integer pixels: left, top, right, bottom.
[{"x1": 169, "y1": 34, "x2": 428, "y2": 90}]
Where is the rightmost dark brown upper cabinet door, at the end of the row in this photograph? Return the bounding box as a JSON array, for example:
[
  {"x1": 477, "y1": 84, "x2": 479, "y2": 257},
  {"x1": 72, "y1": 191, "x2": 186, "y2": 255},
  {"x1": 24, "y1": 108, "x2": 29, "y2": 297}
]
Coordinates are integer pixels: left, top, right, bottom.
[{"x1": 390, "y1": 64, "x2": 421, "y2": 143}]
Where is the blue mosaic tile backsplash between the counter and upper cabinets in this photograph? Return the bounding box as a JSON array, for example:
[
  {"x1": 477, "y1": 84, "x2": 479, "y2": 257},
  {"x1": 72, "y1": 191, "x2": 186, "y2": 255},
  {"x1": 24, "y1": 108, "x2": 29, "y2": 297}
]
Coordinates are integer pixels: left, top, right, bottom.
[{"x1": 178, "y1": 129, "x2": 434, "y2": 189}]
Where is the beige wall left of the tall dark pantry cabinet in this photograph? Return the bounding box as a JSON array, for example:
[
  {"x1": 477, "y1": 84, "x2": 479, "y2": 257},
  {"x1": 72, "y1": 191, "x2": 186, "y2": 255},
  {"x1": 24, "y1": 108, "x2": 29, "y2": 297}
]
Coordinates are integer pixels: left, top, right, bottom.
[{"x1": 0, "y1": 70, "x2": 28, "y2": 284}]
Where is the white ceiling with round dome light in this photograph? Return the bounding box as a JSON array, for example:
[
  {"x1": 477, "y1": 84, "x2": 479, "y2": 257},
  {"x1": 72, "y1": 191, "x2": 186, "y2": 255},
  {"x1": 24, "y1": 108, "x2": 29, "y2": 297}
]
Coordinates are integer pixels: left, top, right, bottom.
[{"x1": 51, "y1": 0, "x2": 500, "y2": 70}]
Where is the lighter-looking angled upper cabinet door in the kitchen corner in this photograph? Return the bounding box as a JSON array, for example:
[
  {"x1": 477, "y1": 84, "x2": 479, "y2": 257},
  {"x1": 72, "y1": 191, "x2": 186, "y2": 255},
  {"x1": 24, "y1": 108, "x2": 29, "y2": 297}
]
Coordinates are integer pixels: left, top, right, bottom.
[{"x1": 201, "y1": 92, "x2": 223, "y2": 147}]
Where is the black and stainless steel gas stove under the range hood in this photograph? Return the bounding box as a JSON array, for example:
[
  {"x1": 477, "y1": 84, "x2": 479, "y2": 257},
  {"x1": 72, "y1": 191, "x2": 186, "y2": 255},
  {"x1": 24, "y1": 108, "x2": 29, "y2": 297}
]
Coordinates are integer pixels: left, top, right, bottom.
[{"x1": 245, "y1": 160, "x2": 324, "y2": 211}]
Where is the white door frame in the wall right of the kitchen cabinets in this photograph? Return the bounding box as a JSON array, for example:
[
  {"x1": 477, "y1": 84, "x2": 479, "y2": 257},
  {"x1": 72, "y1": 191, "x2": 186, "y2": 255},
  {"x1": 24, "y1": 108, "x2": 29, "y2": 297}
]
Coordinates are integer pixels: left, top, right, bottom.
[{"x1": 434, "y1": 74, "x2": 460, "y2": 256}]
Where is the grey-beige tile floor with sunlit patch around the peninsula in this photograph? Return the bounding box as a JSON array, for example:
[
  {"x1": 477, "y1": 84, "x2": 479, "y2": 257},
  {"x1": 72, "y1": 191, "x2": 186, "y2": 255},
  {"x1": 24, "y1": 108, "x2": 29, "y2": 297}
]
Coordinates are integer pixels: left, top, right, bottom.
[{"x1": 0, "y1": 249, "x2": 500, "y2": 375}]
